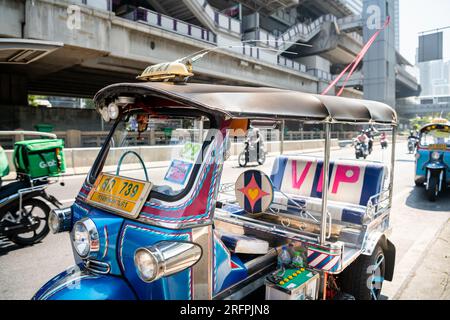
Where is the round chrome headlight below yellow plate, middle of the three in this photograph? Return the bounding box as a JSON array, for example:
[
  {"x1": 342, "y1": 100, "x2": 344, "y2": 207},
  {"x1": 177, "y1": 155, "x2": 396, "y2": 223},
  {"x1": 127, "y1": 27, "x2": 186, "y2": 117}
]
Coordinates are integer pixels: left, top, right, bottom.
[{"x1": 72, "y1": 218, "x2": 100, "y2": 258}]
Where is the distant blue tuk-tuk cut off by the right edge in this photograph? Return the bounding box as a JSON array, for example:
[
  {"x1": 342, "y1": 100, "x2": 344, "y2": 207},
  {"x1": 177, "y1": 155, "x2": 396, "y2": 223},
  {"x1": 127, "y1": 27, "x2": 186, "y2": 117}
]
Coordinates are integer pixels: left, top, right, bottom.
[{"x1": 415, "y1": 119, "x2": 450, "y2": 202}]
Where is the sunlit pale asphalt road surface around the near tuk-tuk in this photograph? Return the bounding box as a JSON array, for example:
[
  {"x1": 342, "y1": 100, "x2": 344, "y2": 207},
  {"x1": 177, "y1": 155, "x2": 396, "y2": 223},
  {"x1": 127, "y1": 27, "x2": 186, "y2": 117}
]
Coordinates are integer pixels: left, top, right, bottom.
[{"x1": 0, "y1": 143, "x2": 450, "y2": 299}]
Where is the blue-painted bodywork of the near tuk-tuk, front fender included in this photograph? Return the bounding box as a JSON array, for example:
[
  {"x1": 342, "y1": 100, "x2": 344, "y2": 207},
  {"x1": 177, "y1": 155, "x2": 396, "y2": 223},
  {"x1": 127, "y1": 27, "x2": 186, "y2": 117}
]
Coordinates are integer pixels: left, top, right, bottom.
[{"x1": 34, "y1": 195, "x2": 247, "y2": 300}]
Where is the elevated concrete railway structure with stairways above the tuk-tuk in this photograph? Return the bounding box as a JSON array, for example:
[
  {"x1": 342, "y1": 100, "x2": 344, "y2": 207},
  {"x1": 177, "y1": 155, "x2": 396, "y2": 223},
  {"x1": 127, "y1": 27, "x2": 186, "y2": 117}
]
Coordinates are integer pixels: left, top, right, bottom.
[{"x1": 0, "y1": 0, "x2": 418, "y2": 109}]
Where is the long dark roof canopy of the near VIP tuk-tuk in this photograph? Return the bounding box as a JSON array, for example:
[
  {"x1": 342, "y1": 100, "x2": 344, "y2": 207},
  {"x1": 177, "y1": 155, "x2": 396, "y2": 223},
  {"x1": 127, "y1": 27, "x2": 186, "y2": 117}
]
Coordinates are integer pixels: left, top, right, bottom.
[{"x1": 94, "y1": 82, "x2": 397, "y2": 125}]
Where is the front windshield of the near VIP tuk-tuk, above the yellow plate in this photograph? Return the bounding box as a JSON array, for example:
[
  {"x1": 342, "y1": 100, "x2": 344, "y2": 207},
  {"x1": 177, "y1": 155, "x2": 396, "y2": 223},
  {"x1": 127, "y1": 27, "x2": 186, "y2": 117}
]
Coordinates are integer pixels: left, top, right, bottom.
[{"x1": 98, "y1": 113, "x2": 208, "y2": 196}]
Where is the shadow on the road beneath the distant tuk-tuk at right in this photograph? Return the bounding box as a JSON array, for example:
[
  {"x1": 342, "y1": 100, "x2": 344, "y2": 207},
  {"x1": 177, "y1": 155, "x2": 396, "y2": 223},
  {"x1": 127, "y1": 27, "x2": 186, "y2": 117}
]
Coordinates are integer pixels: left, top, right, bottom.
[{"x1": 406, "y1": 187, "x2": 450, "y2": 212}]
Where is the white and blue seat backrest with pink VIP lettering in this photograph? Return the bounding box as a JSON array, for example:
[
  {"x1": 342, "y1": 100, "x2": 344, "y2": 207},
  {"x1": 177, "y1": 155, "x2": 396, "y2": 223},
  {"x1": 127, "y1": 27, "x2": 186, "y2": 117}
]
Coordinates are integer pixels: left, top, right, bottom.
[{"x1": 271, "y1": 156, "x2": 387, "y2": 206}]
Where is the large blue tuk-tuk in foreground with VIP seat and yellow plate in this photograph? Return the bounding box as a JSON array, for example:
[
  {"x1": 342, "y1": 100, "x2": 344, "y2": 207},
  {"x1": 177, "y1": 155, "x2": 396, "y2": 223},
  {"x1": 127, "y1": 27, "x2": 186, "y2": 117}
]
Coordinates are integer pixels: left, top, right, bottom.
[{"x1": 34, "y1": 63, "x2": 397, "y2": 300}]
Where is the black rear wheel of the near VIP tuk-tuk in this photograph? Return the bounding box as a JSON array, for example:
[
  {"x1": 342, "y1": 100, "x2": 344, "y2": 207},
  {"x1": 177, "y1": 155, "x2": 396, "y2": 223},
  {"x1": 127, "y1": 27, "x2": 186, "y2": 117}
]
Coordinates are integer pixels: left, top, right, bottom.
[{"x1": 341, "y1": 244, "x2": 386, "y2": 300}]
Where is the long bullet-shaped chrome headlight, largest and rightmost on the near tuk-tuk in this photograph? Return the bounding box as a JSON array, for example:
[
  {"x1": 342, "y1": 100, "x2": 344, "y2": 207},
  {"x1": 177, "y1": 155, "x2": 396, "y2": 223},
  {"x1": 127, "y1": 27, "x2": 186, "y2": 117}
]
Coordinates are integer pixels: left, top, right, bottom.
[{"x1": 134, "y1": 241, "x2": 202, "y2": 282}]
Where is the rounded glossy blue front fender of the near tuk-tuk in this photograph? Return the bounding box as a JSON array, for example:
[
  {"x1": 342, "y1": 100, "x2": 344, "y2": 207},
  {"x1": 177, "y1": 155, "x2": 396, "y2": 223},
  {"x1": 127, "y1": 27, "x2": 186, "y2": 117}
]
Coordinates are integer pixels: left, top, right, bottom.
[{"x1": 32, "y1": 266, "x2": 137, "y2": 300}]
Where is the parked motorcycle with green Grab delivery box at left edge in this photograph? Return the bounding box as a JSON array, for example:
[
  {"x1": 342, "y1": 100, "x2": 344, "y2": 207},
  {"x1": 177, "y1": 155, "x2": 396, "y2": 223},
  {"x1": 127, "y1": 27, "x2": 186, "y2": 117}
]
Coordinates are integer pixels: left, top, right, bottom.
[{"x1": 0, "y1": 139, "x2": 65, "y2": 245}]
